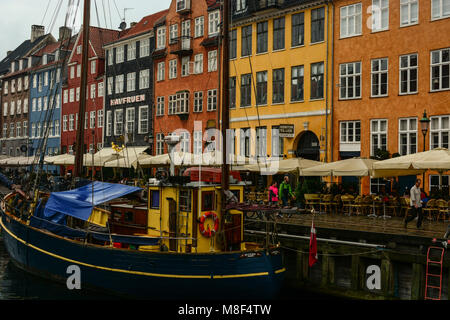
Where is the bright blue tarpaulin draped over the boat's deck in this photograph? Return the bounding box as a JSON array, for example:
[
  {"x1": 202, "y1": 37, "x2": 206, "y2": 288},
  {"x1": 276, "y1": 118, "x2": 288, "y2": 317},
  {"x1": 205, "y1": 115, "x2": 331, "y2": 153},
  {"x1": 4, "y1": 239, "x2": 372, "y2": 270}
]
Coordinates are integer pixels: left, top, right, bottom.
[{"x1": 44, "y1": 181, "x2": 142, "y2": 221}]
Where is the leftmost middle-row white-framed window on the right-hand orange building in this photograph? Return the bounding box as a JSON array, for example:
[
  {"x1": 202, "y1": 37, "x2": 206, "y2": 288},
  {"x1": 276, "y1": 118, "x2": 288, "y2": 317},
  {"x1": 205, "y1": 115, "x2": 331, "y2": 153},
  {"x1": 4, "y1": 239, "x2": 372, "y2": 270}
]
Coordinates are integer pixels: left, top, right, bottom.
[{"x1": 339, "y1": 62, "x2": 361, "y2": 99}]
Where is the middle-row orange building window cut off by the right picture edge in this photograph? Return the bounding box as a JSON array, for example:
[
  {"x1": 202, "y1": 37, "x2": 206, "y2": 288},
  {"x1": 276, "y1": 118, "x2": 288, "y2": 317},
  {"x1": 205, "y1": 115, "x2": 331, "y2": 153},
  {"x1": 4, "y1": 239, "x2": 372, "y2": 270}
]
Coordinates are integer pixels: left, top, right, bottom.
[{"x1": 431, "y1": 48, "x2": 450, "y2": 91}]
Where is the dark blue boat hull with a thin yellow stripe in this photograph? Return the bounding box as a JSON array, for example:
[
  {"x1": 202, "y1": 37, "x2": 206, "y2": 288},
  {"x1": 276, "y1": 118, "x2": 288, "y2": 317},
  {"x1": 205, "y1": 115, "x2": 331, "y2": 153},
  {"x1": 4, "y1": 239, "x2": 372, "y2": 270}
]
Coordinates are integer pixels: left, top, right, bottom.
[{"x1": 0, "y1": 211, "x2": 285, "y2": 300}]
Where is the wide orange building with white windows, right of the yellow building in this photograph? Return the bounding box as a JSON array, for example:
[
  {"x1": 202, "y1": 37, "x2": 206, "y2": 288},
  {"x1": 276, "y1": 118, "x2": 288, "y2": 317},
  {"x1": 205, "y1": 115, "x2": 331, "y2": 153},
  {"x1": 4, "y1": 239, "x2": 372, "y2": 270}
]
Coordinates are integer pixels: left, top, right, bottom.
[{"x1": 332, "y1": 0, "x2": 450, "y2": 193}]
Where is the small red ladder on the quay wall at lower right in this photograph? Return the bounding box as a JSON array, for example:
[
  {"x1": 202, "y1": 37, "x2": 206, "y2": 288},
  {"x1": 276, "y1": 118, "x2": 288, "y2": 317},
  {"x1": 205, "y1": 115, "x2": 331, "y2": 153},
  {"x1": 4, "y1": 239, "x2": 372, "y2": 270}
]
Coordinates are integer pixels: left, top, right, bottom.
[{"x1": 425, "y1": 247, "x2": 444, "y2": 300}]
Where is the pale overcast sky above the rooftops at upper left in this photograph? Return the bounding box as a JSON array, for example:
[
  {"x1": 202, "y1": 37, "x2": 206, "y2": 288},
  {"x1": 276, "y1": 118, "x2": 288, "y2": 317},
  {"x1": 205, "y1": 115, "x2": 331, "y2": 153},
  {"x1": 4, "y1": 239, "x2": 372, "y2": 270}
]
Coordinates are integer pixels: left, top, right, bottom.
[{"x1": 0, "y1": 0, "x2": 171, "y2": 60}]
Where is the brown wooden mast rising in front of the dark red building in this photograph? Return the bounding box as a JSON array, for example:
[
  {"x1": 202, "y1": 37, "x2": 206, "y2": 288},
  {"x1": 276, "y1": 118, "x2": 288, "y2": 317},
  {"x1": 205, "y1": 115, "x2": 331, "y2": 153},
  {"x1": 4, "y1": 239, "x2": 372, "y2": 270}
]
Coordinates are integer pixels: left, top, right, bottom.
[{"x1": 74, "y1": 0, "x2": 91, "y2": 177}]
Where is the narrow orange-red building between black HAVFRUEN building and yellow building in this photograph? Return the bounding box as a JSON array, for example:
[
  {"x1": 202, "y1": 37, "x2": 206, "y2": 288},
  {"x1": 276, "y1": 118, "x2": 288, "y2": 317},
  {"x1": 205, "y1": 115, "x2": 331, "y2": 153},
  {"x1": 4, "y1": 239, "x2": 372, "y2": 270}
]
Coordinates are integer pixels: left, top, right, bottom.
[{"x1": 153, "y1": 0, "x2": 220, "y2": 154}]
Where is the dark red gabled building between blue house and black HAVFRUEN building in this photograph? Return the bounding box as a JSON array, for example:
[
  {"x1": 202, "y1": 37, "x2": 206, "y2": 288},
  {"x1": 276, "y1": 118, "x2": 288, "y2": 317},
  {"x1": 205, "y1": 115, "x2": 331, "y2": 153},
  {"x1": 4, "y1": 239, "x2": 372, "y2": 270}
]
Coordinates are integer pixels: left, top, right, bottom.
[{"x1": 61, "y1": 27, "x2": 120, "y2": 158}]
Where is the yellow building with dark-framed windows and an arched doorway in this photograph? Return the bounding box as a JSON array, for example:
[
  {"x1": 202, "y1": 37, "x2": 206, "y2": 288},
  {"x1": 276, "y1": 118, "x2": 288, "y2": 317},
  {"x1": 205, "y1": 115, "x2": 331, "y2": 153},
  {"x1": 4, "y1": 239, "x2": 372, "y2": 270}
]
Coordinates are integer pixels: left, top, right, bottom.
[{"x1": 230, "y1": 0, "x2": 333, "y2": 161}]
